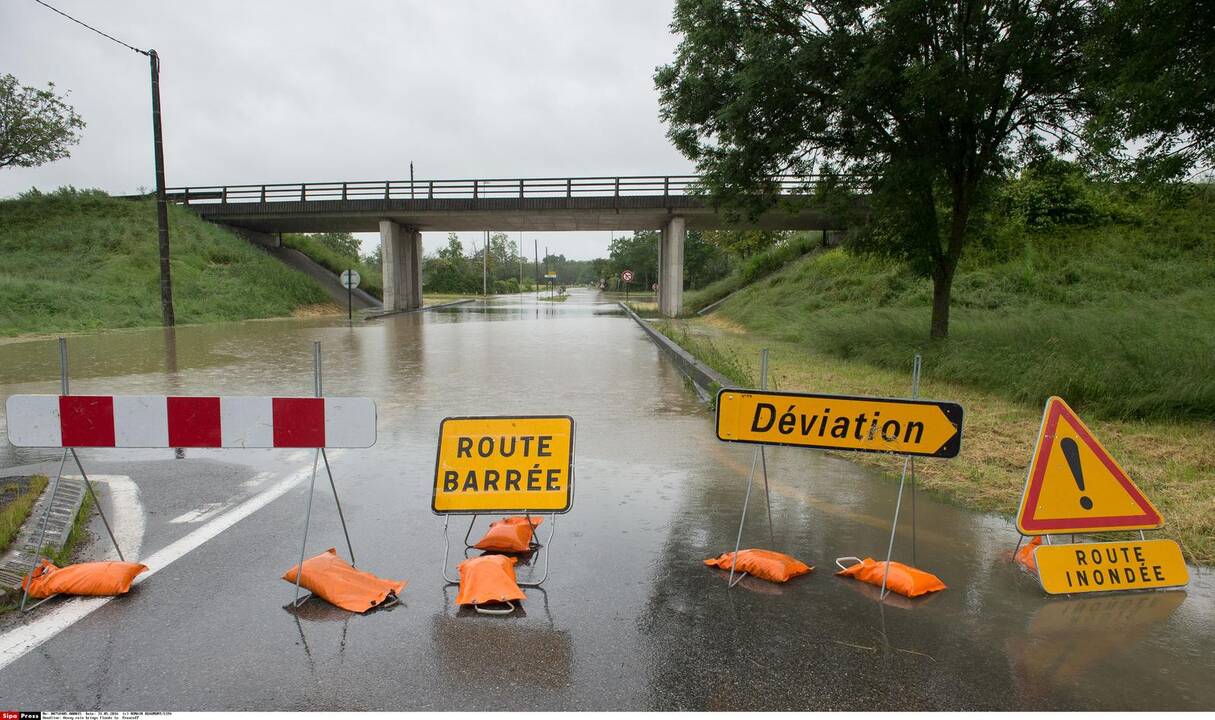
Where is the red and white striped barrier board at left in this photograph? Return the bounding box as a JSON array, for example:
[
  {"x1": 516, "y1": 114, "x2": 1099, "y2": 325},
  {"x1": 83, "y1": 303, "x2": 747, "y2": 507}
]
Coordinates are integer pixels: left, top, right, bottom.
[{"x1": 6, "y1": 395, "x2": 375, "y2": 448}]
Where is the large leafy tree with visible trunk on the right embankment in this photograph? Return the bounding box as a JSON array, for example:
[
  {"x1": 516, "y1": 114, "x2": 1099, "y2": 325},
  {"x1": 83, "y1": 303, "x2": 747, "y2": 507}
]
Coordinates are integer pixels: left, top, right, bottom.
[{"x1": 655, "y1": 0, "x2": 1097, "y2": 338}]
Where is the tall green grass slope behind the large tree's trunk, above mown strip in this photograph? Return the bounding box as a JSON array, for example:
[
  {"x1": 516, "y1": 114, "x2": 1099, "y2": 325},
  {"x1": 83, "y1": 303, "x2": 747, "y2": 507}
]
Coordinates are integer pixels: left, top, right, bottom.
[{"x1": 717, "y1": 192, "x2": 1215, "y2": 420}]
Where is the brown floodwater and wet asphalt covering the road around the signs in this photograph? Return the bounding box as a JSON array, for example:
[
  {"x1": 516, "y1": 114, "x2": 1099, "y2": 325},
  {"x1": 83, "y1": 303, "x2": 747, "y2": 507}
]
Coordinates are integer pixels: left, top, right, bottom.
[{"x1": 0, "y1": 290, "x2": 1215, "y2": 710}]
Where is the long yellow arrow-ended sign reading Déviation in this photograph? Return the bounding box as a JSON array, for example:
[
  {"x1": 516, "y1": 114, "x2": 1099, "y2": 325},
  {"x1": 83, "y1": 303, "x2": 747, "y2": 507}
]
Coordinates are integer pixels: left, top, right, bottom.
[{"x1": 717, "y1": 389, "x2": 962, "y2": 458}]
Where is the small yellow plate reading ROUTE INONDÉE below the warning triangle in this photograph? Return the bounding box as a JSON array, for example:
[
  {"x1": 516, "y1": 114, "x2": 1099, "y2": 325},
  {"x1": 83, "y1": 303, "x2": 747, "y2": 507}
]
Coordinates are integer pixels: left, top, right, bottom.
[{"x1": 1034, "y1": 540, "x2": 1189, "y2": 595}]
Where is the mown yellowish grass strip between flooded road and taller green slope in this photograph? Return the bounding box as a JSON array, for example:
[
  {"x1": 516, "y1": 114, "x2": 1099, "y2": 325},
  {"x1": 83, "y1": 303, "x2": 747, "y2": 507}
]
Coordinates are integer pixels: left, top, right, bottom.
[{"x1": 660, "y1": 316, "x2": 1215, "y2": 566}]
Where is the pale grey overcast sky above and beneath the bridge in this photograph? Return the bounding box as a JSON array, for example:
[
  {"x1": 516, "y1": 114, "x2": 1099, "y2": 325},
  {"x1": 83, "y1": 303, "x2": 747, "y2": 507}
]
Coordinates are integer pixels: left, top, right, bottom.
[{"x1": 0, "y1": 0, "x2": 693, "y2": 259}]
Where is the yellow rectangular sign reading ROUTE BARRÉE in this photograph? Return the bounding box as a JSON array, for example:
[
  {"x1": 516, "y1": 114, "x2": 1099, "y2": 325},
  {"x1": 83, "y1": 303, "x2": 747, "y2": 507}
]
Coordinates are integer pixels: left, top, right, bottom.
[{"x1": 430, "y1": 415, "x2": 573, "y2": 514}]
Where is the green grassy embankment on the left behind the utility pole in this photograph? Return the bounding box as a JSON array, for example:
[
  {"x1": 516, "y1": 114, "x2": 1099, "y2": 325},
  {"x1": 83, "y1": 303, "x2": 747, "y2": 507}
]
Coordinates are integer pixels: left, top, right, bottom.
[{"x1": 0, "y1": 191, "x2": 337, "y2": 335}]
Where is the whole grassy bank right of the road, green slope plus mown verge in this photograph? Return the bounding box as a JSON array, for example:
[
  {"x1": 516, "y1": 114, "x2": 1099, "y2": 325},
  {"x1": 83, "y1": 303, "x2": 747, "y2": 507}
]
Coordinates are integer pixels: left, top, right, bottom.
[{"x1": 666, "y1": 193, "x2": 1215, "y2": 565}]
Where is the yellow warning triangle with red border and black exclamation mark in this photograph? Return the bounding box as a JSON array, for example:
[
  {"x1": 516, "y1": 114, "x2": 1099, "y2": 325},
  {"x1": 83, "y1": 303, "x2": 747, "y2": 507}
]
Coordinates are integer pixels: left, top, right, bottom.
[{"x1": 1017, "y1": 397, "x2": 1164, "y2": 535}]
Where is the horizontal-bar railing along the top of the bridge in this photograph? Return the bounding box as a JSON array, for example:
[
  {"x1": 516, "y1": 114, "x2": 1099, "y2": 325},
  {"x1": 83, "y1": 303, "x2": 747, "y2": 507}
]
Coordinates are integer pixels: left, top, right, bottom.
[{"x1": 166, "y1": 175, "x2": 855, "y2": 205}]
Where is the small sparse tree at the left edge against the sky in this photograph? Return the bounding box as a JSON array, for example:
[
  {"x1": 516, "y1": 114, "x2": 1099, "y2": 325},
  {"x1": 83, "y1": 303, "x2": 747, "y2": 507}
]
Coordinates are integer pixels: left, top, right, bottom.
[{"x1": 0, "y1": 75, "x2": 84, "y2": 168}]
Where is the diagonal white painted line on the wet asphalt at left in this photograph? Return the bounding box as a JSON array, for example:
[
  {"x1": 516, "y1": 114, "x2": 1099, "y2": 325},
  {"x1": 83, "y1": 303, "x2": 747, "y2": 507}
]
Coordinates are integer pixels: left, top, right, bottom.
[{"x1": 0, "y1": 453, "x2": 339, "y2": 670}]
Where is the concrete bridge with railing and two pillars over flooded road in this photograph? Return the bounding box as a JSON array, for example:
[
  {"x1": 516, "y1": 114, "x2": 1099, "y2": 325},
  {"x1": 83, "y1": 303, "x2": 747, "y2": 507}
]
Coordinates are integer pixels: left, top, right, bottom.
[{"x1": 169, "y1": 175, "x2": 843, "y2": 317}]
